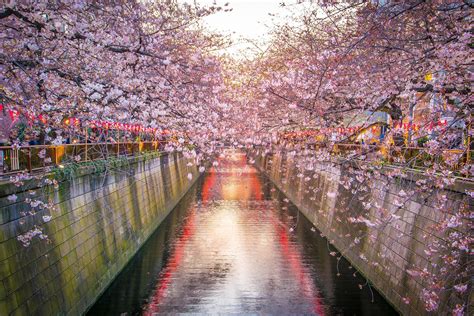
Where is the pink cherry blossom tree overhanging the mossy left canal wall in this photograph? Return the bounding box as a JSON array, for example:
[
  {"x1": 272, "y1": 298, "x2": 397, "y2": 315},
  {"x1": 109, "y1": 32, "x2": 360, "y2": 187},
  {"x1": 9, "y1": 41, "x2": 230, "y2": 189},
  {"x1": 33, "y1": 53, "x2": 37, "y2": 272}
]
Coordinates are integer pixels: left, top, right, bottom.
[{"x1": 0, "y1": 1, "x2": 231, "y2": 144}]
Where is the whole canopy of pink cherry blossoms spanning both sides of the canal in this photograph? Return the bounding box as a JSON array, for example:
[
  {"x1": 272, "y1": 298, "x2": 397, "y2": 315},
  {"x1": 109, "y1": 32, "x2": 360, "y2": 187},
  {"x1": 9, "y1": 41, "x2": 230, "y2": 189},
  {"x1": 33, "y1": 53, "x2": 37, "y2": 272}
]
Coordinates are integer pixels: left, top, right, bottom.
[{"x1": 0, "y1": 0, "x2": 474, "y2": 312}]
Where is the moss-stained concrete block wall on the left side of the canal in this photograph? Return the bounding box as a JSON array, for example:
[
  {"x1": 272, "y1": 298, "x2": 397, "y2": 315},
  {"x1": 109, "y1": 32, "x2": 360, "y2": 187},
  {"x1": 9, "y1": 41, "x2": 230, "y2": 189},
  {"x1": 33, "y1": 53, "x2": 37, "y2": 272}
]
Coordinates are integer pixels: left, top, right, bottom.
[{"x1": 0, "y1": 154, "x2": 199, "y2": 315}]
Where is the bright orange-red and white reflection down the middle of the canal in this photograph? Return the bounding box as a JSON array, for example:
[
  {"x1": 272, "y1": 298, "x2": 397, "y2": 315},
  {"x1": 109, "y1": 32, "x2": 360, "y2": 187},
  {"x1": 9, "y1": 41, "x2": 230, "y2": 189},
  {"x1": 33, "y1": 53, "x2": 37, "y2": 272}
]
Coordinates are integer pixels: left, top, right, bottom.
[{"x1": 144, "y1": 154, "x2": 325, "y2": 315}]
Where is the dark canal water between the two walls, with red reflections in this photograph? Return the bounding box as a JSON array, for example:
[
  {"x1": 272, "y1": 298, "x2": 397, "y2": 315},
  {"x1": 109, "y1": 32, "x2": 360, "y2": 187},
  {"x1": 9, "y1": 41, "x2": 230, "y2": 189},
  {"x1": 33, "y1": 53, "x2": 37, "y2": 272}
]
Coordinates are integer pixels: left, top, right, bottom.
[{"x1": 88, "y1": 152, "x2": 396, "y2": 315}]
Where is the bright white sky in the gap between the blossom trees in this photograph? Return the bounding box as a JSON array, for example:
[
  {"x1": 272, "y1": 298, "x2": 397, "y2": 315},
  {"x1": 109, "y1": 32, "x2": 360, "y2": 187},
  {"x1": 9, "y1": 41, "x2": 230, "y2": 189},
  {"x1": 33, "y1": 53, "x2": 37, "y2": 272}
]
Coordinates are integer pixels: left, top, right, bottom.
[{"x1": 179, "y1": 0, "x2": 304, "y2": 55}]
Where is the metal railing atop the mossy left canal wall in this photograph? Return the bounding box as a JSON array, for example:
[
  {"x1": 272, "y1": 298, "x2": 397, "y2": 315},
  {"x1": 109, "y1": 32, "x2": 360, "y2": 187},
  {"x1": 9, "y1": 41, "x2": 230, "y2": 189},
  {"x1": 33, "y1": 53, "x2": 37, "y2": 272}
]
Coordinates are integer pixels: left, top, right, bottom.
[{"x1": 0, "y1": 141, "x2": 166, "y2": 175}]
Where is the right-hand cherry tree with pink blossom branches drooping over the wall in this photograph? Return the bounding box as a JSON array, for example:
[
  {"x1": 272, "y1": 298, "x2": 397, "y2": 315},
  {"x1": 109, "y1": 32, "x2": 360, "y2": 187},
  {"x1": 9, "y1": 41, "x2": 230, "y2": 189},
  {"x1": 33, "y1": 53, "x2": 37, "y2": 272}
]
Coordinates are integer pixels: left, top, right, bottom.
[{"x1": 234, "y1": 0, "x2": 474, "y2": 313}]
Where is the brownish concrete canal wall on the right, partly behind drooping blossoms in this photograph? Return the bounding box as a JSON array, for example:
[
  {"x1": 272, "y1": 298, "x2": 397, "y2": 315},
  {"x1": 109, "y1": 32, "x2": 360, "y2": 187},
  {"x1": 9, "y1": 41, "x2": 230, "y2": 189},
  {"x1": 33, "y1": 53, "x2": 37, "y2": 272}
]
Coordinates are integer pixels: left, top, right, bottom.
[{"x1": 258, "y1": 152, "x2": 473, "y2": 315}]
